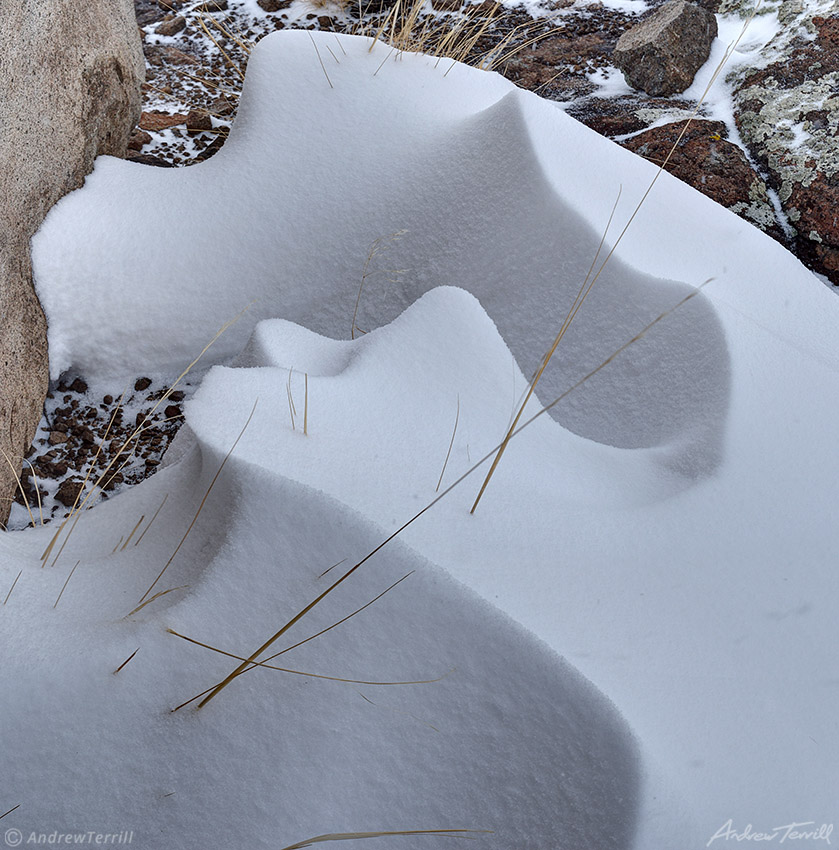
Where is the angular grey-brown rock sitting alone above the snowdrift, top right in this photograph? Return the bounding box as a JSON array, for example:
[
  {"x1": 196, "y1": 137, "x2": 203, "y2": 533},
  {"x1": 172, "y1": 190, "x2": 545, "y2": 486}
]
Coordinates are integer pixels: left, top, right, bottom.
[{"x1": 612, "y1": 0, "x2": 717, "y2": 97}]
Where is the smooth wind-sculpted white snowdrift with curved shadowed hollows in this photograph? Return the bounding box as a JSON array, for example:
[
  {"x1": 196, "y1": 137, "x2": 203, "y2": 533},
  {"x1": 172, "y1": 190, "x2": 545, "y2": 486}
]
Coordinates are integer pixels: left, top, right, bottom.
[{"x1": 0, "y1": 32, "x2": 839, "y2": 850}]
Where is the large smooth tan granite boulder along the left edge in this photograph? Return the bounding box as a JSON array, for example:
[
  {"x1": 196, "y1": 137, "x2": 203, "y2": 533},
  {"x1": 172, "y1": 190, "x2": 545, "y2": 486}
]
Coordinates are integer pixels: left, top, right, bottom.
[{"x1": 0, "y1": 0, "x2": 145, "y2": 521}]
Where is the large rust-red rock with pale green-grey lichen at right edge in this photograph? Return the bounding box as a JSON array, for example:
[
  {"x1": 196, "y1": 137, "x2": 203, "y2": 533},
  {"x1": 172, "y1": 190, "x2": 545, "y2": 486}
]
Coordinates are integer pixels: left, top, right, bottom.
[{"x1": 733, "y1": 5, "x2": 839, "y2": 285}]
